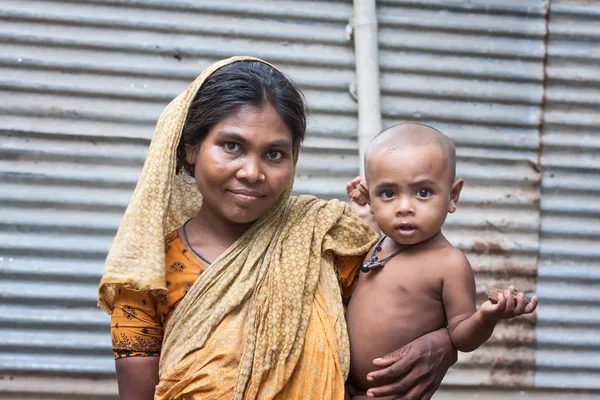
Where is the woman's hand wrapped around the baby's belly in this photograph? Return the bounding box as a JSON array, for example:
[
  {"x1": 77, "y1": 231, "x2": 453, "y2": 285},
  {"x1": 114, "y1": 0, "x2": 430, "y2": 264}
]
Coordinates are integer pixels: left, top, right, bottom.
[{"x1": 367, "y1": 328, "x2": 457, "y2": 400}]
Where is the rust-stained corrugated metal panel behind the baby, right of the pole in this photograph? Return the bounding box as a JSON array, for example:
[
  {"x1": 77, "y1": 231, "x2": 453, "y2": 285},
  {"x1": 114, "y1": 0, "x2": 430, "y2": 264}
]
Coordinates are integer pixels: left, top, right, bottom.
[{"x1": 378, "y1": 0, "x2": 546, "y2": 398}]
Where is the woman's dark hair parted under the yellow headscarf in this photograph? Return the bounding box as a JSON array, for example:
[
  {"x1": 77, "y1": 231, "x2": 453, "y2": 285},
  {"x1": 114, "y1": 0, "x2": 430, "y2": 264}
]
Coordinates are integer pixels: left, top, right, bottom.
[{"x1": 177, "y1": 61, "x2": 306, "y2": 176}]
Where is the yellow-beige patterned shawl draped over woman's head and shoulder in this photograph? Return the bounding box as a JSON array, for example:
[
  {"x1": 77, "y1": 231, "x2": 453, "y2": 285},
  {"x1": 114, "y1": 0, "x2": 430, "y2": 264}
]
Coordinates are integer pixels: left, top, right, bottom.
[{"x1": 98, "y1": 57, "x2": 376, "y2": 399}]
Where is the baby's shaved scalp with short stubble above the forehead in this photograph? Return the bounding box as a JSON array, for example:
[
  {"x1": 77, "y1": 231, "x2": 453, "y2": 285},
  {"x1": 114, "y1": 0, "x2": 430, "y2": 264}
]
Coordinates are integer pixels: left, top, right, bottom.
[{"x1": 365, "y1": 122, "x2": 456, "y2": 181}]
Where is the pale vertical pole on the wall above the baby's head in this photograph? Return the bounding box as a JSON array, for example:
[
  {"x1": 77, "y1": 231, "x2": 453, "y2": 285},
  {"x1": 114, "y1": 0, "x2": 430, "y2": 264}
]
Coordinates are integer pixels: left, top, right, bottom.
[{"x1": 354, "y1": 0, "x2": 381, "y2": 176}]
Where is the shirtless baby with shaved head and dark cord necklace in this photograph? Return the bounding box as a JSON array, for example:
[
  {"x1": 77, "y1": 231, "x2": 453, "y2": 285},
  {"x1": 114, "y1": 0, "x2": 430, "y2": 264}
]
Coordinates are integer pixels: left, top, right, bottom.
[{"x1": 346, "y1": 123, "x2": 537, "y2": 399}]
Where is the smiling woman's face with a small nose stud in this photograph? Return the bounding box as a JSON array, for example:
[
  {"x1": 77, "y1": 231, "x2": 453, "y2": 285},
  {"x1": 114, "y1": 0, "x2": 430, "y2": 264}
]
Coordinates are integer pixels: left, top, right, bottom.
[{"x1": 186, "y1": 105, "x2": 294, "y2": 224}]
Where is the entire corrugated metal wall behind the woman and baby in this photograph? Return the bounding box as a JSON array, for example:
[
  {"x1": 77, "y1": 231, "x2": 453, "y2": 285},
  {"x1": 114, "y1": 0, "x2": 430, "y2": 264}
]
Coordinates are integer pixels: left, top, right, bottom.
[{"x1": 0, "y1": 0, "x2": 600, "y2": 399}]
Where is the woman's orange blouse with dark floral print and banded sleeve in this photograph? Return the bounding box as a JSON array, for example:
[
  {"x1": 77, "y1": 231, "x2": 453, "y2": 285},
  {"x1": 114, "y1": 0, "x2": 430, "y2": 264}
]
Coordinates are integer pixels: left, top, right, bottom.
[{"x1": 111, "y1": 231, "x2": 362, "y2": 359}]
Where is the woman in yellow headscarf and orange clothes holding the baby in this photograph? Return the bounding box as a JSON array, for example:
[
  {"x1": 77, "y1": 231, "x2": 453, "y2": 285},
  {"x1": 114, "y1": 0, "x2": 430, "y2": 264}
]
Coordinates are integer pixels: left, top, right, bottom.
[{"x1": 99, "y1": 57, "x2": 456, "y2": 399}]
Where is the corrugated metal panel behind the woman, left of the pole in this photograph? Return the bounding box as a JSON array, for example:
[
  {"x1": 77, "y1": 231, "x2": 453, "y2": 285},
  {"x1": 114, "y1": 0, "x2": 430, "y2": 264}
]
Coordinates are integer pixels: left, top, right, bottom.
[{"x1": 0, "y1": 0, "x2": 358, "y2": 399}]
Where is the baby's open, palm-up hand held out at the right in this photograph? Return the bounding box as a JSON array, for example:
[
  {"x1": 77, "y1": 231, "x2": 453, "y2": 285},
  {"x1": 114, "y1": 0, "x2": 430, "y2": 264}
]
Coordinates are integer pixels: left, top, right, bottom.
[{"x1": 480, "y1": 285, "x2": 537, "y2": 320}]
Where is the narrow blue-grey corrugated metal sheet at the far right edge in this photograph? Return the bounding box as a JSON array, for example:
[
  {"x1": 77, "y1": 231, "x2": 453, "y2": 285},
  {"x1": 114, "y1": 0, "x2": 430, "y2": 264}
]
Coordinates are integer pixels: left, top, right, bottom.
[{"x1": 535, "y1": 0, "x2": 600, "y2": 393}]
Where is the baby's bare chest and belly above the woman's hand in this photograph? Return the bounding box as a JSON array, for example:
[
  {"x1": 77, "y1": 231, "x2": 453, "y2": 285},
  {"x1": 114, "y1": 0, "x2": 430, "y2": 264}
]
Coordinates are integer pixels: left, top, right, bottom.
[{"x1": 346, "y1": 253, "x2": 446, "y2": 385}]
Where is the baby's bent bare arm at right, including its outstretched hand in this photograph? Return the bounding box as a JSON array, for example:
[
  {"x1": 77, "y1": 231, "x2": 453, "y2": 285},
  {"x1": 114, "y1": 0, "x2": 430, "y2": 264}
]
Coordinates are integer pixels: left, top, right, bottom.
[{"x1": 442, "y1": 249, "x2": 537, "y2": 352}]
